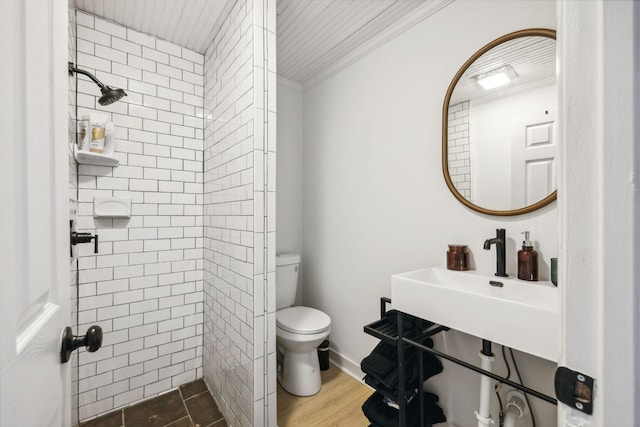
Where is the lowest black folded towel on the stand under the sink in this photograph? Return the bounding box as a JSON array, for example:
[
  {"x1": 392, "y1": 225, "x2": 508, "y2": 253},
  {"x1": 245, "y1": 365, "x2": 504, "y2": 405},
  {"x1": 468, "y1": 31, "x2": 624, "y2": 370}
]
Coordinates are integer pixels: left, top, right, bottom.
[{"x1": 362, "y1": 392, "x2": 447, "y2": 427}]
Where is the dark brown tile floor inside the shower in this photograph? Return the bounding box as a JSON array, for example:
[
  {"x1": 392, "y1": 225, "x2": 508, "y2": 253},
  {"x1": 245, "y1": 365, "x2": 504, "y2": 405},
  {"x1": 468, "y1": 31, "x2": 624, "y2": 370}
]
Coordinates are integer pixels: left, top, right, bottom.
[{"x1": 81, "y1": 380, "x2": 227, "y2": 427}]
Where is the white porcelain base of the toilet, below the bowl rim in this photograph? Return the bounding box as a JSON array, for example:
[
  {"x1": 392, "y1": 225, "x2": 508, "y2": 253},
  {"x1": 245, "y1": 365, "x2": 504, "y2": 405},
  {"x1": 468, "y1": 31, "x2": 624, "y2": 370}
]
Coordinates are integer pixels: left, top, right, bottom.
[{"x1": 278, "y1": 348, "x2": 322, "y2": 396}]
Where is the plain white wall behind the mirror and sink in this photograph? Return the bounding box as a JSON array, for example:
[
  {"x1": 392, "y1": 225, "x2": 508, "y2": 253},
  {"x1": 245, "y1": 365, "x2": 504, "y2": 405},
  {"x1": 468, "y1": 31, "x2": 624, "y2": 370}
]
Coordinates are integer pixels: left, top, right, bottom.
[{"x1": 302, "y1": 1, "x2": 558, "y2": 426}]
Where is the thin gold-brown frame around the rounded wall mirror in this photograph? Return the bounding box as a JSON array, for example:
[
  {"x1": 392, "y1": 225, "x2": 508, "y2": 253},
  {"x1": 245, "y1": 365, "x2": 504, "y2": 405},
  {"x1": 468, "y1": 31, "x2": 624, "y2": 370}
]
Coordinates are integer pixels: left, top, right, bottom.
[{"x1": 442, "y1": 28, "x2": 558, "y2": 216}]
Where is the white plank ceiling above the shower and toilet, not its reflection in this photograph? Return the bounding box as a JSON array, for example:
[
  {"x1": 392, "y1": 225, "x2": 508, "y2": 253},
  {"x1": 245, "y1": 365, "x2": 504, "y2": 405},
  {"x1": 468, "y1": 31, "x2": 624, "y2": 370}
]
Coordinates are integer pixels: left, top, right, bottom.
[{"x1": 76, "y1": 0, "x2": 452, "y2": 83}]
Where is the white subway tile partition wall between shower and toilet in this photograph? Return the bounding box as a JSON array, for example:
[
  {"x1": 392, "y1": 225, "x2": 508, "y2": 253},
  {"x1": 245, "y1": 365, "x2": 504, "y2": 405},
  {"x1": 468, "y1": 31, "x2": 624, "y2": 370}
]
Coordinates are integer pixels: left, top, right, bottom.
[{"x1": 203, "y1": 0, "x2": 277, "y2": 426}]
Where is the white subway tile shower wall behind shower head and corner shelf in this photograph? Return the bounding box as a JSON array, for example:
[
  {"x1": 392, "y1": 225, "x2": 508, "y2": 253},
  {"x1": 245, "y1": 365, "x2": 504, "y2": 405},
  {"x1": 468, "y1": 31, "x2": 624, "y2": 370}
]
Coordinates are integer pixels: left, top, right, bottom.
[{"x1": 70, "y1": 11, "x2": 204, "y2": 420}]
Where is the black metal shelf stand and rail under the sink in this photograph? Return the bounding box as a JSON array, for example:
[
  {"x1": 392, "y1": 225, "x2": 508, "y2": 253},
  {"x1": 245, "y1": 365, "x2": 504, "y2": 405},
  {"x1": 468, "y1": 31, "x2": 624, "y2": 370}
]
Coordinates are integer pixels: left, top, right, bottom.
[{"x1": 364, "y1": 297, "x2": 558, "y2": 427}]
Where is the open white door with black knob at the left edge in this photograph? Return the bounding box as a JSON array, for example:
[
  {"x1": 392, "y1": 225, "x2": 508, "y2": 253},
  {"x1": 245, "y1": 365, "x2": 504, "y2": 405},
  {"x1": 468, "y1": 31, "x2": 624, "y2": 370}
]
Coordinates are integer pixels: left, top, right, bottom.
[{"x1": 0, "y1": 0, "x2": 70, "y2": 427}]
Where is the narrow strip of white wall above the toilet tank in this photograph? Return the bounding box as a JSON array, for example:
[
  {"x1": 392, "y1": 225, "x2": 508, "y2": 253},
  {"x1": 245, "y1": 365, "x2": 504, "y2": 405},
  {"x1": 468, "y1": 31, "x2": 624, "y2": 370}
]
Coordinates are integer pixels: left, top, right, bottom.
[{"x1": 276, "y1": 78, "x2": 303, "y2": 253}]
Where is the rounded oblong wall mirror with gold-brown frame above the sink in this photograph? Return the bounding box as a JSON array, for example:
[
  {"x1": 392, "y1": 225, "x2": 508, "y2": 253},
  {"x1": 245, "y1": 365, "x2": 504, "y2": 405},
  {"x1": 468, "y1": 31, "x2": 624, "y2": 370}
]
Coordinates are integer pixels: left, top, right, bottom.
[{"x1": 442, "y1": 29, "x2": 557, "y2": 215}]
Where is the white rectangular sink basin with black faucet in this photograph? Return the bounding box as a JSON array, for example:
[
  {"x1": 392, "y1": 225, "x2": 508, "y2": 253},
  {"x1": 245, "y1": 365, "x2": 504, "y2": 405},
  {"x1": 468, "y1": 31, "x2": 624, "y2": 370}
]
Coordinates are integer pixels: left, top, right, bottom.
[{"x1": 391, "y1": 267, "x2": 560, "y2": 362}]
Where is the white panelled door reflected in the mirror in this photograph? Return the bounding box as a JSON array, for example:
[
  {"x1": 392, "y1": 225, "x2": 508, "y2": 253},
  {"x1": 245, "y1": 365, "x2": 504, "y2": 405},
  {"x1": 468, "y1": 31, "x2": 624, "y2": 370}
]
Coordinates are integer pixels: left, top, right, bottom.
[{"x1": 511, "y1": 110, "x2": 558, "y2": 207}]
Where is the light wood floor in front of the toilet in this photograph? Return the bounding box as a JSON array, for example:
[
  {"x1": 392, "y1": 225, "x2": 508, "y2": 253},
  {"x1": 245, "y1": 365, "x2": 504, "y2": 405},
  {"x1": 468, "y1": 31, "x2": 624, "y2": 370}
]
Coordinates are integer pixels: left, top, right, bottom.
[{"x1": 278, "y1": 365, "x2": 373, "y2": 427}]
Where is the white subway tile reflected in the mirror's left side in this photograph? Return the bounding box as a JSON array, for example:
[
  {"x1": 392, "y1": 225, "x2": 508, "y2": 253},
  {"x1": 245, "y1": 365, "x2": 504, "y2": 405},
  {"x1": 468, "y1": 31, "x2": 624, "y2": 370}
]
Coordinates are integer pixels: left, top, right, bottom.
[{"x1": 447, "y1": 101, "x2": 473, "y2": 202}]
